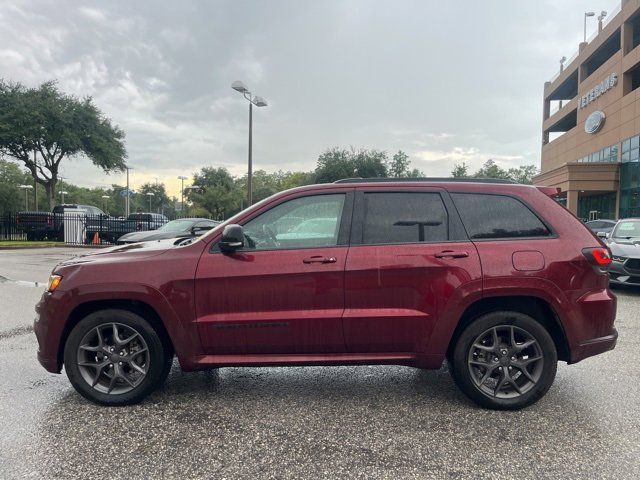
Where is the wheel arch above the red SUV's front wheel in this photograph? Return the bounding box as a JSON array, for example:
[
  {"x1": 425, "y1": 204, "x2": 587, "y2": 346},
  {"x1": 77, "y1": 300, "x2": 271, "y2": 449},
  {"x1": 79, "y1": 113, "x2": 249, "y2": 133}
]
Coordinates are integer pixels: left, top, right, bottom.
[{"x1": 57, "y1": 299, "x2": 175, "y2": 369}]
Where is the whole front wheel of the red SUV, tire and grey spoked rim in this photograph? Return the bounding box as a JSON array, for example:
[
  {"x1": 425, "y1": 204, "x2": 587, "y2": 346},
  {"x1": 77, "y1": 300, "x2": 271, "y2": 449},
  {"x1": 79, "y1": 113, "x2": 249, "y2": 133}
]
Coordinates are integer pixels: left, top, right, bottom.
[{"x1": 64, "y1": 309, "x2": 173, "y2": 405}]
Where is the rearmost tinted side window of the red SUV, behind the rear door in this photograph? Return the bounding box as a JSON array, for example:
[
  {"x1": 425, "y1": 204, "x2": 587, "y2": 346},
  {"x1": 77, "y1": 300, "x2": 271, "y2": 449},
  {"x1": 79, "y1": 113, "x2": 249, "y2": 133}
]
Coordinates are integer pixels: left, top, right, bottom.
[{"x1": 451, "y1": 193, "x2": 551, "y2": 240}]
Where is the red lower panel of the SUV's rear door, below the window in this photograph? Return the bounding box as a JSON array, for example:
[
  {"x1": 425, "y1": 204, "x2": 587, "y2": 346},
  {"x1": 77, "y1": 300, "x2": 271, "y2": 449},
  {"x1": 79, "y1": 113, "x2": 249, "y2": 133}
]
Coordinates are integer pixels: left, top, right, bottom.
[{"x1": 343, "y1": 242, "x2": 481, "y2": 352}]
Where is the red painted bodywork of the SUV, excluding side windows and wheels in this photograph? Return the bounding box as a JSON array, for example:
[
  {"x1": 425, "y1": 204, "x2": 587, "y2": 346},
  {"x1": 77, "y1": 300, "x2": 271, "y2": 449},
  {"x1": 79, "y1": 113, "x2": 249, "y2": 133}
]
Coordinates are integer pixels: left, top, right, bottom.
[{"x1": 35, "y1": 182, "x2": 617, "y2": 372}]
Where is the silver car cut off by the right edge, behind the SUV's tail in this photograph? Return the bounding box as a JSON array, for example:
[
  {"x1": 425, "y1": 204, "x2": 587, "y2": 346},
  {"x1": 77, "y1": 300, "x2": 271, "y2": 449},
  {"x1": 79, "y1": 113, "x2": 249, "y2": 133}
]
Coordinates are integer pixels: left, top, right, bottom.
[{"x1": 606, "y1": 218, "x2": 640, "y2": 286}]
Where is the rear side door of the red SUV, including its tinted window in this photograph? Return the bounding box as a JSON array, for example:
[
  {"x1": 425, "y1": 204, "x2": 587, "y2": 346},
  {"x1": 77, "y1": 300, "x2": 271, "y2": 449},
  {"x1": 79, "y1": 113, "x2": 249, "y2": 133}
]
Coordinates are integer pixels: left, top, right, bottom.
[{"x1": 343, "y1": 188, "x2": 481, "y2": 353}]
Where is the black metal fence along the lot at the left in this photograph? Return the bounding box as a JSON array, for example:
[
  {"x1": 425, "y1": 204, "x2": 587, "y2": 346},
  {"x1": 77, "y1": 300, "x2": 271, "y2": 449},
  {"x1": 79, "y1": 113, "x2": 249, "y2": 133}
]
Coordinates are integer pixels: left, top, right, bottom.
[{"x1": 0, "y1": 212, "x2": 166, "y2": 245}]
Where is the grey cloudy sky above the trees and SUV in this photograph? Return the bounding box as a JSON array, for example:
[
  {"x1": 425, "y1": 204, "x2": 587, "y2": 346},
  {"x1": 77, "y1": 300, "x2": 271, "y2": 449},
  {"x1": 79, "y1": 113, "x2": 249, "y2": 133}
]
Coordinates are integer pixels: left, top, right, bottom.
[{"x1": 0, "y1": 0, "x2": 617, "y2": 194}]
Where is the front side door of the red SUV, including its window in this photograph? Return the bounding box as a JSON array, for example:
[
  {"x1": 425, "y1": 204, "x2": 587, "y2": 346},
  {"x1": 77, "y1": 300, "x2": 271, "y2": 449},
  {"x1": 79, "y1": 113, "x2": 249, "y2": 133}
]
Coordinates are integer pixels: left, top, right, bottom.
[{"x1": 195, "y1": 189, "x2": 353, "y2": 354}]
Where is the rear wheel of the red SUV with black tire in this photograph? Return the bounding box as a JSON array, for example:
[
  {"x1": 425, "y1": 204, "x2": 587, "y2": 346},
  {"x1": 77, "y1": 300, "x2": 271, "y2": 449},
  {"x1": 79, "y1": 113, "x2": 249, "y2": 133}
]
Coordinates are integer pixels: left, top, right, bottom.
[{"x1": 450, "y1": 311, "x2": 558, "y2": 410}]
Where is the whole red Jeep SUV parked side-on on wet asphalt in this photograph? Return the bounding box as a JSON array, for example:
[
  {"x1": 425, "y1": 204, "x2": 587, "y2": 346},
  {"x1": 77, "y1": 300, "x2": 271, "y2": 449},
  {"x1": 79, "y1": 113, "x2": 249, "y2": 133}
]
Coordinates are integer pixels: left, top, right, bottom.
[{"x1": 35, "y1": 179, "x2": 617, "y2": 409}]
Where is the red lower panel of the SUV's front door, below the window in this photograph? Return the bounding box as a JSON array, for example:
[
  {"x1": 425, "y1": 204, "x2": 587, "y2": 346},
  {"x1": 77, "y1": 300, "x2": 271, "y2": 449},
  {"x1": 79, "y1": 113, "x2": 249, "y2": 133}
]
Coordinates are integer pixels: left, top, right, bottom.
[{"x1": 195, "y1": 247, "x2": 348, "y2": 354}]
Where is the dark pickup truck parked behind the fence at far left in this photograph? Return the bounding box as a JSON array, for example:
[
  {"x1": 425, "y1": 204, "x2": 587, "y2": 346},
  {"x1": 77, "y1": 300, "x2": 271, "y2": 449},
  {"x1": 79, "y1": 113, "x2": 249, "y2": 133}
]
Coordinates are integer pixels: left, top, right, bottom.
[{"x1": 16, "y1": 203, "x2": 106, "y2": 240}]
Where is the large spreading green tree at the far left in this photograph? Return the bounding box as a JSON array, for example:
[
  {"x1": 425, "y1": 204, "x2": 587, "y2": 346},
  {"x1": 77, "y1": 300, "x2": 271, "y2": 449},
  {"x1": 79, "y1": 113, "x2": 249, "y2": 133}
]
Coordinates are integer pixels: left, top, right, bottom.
[{"x1": 0, "y1": 80, "x2": 126, "y2": 209}]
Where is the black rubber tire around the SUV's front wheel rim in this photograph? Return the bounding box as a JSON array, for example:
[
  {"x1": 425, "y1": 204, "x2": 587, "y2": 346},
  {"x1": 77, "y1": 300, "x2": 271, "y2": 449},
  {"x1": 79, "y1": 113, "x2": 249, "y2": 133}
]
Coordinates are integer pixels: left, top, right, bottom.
[{"x1": 64, "y1": 309, "x2": 173, "y2": 406}]
